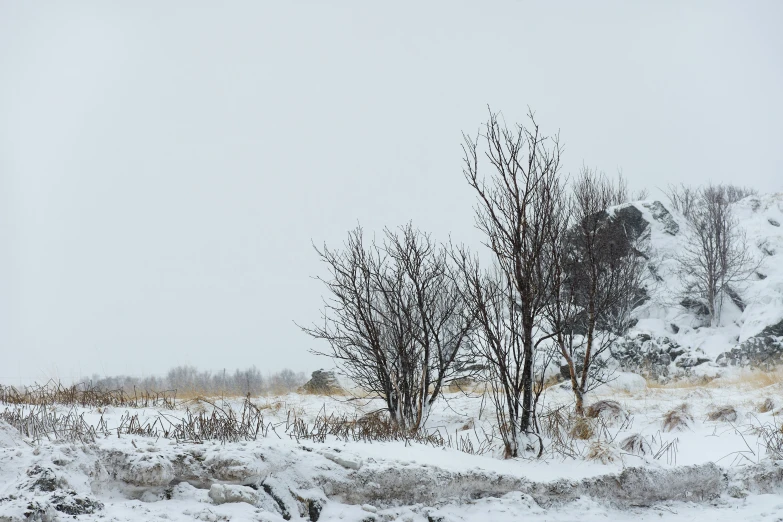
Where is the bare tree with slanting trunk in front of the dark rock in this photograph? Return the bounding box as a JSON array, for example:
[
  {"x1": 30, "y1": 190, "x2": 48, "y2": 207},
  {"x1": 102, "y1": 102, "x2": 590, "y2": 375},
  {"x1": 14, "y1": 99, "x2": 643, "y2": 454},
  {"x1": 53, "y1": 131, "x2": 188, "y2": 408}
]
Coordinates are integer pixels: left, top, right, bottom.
[{"x1": 547, "y1": 168, "x2": 645, "y2": 415}]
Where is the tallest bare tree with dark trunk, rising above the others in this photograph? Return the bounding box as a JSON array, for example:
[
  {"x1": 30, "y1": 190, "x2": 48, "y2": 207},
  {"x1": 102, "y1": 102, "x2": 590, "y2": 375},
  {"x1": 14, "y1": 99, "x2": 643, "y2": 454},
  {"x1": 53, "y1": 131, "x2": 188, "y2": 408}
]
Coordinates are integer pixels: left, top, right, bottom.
[{"x1": 463, "y1": 110, "x2": 562, "y2": 433}]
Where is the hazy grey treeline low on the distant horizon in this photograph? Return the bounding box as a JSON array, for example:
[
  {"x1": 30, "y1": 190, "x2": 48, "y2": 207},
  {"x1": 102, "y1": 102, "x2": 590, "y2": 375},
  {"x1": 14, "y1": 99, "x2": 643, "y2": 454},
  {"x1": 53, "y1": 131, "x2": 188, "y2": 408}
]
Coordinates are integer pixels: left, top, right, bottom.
[{"x1": 90, "y1": 366, "x2": 307, "y2": 395}]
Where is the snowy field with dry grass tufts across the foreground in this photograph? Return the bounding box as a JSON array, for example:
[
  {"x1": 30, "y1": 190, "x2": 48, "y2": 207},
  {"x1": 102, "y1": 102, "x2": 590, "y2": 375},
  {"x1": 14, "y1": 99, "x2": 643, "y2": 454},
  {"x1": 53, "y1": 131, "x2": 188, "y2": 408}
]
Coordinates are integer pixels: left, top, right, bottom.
[{"x1": 0, "y1": 374, "x2": 783, "y2": 522}]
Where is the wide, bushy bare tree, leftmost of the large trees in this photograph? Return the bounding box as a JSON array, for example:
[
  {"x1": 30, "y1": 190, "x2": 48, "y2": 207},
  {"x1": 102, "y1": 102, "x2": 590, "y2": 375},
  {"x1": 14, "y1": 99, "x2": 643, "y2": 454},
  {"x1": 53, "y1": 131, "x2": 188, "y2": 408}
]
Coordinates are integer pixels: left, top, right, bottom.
[{"x1": 303, "y1": 221, "x2": 472, "y2": 430}]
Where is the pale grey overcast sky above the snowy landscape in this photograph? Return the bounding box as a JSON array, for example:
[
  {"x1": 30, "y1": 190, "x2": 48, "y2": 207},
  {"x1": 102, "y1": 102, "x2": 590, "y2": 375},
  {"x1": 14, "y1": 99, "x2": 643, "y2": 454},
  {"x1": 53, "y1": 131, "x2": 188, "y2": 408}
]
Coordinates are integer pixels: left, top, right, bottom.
[{"x1": 0, "y1": 0, "x2": 783, "y2": 383}]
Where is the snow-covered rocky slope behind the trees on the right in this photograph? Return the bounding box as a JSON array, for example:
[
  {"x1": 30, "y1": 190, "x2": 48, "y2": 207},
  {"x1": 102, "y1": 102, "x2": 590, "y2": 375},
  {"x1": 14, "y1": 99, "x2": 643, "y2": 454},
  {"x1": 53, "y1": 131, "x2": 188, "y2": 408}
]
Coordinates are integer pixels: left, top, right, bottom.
[{"x1": 610, "y1": 193, "x2": 783, "y2": 379}]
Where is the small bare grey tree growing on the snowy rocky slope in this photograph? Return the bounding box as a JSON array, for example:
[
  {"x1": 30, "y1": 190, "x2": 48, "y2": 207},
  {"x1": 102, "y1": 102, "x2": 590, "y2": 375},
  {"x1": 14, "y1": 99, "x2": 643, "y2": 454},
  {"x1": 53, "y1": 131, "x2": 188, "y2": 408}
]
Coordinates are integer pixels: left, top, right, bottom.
[{"x1": 677, "y1": 185, "x2": 758, "y2": 320}]
